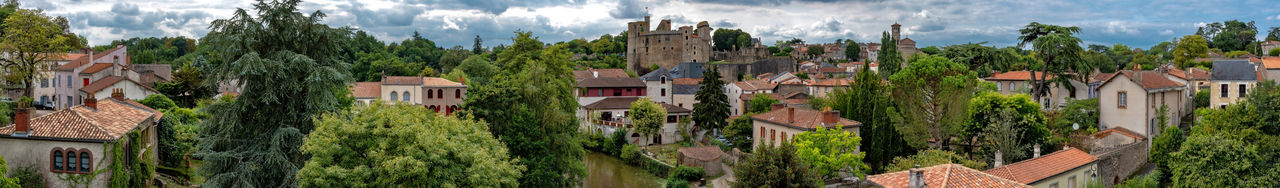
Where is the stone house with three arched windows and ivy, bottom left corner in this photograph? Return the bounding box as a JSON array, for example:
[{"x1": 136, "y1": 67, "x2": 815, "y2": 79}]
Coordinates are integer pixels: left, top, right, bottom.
[{"x1": 0, "y1": 90, "x2": 163, "y2": 187}]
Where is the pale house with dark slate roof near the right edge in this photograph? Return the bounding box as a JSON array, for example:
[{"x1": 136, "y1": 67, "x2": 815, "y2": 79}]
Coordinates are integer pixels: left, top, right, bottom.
[{"x1": 1208, "y1": 60, "x2": 1263, "y2": 107}]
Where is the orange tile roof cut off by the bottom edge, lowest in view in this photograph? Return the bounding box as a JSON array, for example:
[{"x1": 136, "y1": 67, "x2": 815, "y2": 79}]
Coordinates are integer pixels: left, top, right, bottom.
[{"x1": 867, "y1": 164, "x2": 1030, "y2": 188}]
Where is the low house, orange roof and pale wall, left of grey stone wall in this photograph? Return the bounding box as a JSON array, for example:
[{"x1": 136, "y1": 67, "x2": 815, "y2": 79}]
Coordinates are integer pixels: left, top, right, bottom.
[{"x1": 983, "y1": 147, "x2": 1098, "y2": 188}]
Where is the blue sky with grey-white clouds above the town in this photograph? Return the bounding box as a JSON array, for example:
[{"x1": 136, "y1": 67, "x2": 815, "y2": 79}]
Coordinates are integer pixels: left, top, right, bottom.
[{"x1": 19, "y1": 0, "x2": 1280, "y2": 49}]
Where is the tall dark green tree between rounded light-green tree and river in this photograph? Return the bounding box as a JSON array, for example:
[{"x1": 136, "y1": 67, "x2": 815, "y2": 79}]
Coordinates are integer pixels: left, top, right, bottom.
[{"x1": 462, "y1": 32, "x2": 586, "y2": 187}]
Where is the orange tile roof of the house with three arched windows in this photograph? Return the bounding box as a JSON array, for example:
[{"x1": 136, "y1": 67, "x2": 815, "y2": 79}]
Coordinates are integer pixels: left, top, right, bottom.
[{"x1": 0, "y1": 98, "x2": 163, "y2": 142}]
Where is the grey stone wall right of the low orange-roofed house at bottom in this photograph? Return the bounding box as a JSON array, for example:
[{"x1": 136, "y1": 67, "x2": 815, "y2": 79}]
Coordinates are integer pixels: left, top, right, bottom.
[{"x1": 1091, "y1": 139, "x2": 1149, "y2": 187}]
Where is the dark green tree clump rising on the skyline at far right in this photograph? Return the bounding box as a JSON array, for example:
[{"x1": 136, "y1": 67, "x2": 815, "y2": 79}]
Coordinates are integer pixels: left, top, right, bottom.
[{"x1": 1196, "y1": 19, "x2": 1258, "y2": 51}]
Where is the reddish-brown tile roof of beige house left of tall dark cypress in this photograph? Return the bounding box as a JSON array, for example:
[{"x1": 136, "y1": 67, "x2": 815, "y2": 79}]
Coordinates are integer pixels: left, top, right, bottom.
[{"x1": 751, "y1": 107, "x2": 863, "y2": 130}]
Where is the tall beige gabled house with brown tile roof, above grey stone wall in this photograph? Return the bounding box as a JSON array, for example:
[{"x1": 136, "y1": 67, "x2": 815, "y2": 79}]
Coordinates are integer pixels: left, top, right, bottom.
[{"x1": 1098, "y1": 70, "x2": 1190, "y2": 142}]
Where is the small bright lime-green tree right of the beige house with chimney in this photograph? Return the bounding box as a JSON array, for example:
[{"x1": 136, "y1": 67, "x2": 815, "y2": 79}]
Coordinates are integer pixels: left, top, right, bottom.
[{"x1": 794, "y1": 125, "x2": 870, "y2": 179}]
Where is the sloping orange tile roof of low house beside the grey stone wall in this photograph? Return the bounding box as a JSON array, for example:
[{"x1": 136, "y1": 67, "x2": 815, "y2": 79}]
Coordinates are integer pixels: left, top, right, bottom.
[{"x1": 984, "y1": 148, "x2": 1098, "y2": 184}]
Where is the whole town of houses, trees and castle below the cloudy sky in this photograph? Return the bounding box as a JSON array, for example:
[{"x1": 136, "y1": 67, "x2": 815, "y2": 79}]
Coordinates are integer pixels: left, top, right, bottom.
[{"x1": 0, "y1": 0, "x2": 1280, "y2": 188}]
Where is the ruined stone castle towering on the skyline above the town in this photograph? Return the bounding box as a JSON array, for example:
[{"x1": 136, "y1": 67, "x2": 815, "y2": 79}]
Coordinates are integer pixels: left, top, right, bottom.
[{"x1": 627, "y1": 17, "x2": 712, "y2": 72}]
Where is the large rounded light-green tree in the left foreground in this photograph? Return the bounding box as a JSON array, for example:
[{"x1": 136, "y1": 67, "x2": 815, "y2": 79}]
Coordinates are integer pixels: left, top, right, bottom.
[{"x1": 298, "y1": 102, "x2": 525, "y2": 187}]
